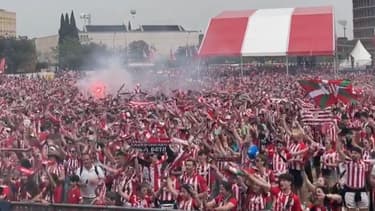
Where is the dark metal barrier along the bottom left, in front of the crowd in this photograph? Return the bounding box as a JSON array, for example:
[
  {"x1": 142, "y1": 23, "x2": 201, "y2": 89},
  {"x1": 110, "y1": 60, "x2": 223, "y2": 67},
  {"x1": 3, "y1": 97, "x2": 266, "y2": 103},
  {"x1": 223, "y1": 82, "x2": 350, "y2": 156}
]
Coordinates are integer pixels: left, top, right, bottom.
[{"x1": 10, "y1": 202, "x2": 173, "y2": 211}]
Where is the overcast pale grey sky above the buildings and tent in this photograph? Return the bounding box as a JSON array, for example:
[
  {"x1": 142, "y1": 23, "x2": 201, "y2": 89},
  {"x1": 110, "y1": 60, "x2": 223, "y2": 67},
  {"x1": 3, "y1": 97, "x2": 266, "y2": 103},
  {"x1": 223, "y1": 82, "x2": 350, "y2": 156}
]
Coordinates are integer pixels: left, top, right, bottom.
[{"x1": 0, "y1": 0, "x2": 352, "y2": 38}]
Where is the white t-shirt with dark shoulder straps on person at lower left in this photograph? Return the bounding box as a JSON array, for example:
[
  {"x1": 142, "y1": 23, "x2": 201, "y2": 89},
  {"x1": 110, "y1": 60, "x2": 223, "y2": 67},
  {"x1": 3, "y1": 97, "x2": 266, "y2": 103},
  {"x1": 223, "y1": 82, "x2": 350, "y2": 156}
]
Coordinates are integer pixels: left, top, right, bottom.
[{"x1": 76, "y1": 164, "x2": 104, "y2": 198}]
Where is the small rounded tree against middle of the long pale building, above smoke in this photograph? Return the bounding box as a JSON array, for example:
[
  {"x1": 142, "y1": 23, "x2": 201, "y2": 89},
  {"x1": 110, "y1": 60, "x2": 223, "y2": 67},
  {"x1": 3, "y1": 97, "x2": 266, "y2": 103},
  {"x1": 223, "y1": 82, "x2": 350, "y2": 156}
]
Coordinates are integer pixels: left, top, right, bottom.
[{"x1": 128, "y1": 40, "x2": 150, "y2": 62}]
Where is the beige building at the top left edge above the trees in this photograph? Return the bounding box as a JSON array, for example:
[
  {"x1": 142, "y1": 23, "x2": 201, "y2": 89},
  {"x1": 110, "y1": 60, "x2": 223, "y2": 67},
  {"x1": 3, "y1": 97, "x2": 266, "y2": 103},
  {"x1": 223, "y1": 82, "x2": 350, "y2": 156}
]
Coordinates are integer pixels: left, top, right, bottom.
[{"x1": 0, "y1": 9, "x2": 17, "y2": 37}]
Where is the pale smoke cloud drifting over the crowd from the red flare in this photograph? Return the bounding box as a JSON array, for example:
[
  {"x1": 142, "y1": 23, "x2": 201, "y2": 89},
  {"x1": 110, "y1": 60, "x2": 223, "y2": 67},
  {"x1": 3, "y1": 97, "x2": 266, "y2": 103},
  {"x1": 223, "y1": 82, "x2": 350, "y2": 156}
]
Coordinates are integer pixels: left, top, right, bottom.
[{"x1": 77, "y1": 52, "x2": 201, "y2": 97}]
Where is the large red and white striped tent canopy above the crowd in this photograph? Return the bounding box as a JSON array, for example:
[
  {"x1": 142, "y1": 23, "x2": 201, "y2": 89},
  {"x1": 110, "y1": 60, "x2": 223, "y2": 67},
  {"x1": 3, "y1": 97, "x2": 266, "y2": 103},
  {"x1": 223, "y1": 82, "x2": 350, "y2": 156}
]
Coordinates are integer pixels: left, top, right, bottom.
[{"x1": 199, "y1": 7, "x2": 335, "y2": 57}]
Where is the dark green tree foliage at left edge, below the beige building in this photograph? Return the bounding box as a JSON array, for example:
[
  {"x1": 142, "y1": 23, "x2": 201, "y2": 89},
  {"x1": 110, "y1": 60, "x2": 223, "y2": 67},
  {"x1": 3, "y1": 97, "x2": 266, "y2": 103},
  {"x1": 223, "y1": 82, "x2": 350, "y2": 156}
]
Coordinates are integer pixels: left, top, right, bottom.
[{"x1": 0, "y1": 38, "x2": 36, "y2": 73}]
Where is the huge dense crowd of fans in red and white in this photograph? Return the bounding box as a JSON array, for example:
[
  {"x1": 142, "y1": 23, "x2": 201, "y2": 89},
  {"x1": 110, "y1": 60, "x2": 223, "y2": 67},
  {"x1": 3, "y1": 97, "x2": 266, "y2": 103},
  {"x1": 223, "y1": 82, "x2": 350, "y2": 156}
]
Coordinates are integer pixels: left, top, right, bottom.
[{"x1": 0, "y1": 70, "x2": 375, "y2": 211}]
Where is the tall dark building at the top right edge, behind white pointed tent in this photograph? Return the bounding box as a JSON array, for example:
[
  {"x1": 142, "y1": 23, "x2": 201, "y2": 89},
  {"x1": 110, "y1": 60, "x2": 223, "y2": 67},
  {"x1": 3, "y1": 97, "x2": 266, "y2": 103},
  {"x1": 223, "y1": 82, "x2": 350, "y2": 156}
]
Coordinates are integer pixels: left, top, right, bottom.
[{"x1": 353, "y1": 0, "x2": 375, "y2": 55}]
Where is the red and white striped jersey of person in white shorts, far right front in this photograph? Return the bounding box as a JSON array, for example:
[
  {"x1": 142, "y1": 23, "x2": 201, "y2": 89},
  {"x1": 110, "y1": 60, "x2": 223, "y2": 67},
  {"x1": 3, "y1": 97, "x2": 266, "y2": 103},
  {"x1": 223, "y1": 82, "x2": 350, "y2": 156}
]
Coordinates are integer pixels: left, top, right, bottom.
[{"x1": 345, "y1": 160, "x2": 366, "y2": 189}]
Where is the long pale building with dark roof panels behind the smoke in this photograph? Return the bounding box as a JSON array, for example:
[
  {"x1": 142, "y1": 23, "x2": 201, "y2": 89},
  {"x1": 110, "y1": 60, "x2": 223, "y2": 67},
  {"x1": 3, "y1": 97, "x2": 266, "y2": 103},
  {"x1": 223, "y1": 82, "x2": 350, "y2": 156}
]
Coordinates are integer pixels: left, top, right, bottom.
[{"x1": 80, "y1": 25, "x2": 199, "y2": 56}]
